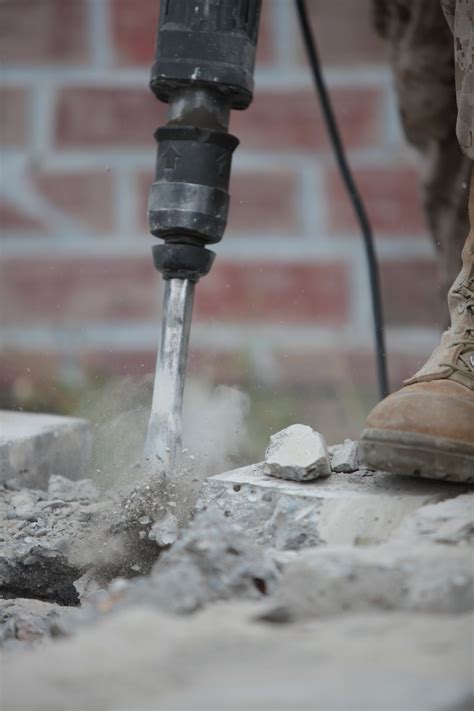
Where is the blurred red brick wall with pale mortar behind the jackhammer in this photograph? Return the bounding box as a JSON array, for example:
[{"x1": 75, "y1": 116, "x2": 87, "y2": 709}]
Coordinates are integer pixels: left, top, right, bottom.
[{"x1": 0, "y1": 0, "x2": 439, "y2": 408}]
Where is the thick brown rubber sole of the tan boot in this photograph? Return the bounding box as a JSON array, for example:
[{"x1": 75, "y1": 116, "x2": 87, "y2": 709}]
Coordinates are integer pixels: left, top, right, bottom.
[{"x1": 359, "y1": 429, "x2": 474, "y2": 483}]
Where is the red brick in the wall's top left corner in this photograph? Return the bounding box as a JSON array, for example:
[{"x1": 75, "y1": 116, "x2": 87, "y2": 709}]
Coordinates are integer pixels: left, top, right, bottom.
[{"x1": 0, "y1": 0, "x2": 88, "y2": 65}]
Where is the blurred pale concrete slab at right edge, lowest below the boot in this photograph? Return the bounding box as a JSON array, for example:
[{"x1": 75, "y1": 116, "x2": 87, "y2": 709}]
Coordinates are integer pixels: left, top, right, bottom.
[{"x1": 262, "y1": 542, "x2": 474, "y2": 622}]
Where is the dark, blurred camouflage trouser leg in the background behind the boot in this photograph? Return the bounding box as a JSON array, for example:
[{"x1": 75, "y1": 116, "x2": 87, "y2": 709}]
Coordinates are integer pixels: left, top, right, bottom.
[{"x1": 373, "y1": 0, "x2": 474, "y2": 325}]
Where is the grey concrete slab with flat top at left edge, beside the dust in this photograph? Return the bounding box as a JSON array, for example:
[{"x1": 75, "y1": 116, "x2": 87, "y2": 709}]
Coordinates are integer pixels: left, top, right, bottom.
[{"x1": 0, "y1": 410, "x2": 92, "y2": 488}]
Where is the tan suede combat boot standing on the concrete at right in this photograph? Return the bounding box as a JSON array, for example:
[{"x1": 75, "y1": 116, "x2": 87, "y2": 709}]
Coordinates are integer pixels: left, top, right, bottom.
[{"x1": 360, "y1": 178, "x2": 474, "y2": 482}]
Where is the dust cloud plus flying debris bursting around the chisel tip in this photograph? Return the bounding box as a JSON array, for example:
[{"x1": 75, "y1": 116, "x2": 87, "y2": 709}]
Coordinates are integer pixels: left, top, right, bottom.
[{"x1": 69, "y1": 377, "x2": 250, "y2": 580}]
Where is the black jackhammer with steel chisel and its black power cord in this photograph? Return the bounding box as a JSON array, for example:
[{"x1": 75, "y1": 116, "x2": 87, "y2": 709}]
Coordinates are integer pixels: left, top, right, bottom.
[{"x1": 144, "y1": 0, "x2": 388, "y2": 475}]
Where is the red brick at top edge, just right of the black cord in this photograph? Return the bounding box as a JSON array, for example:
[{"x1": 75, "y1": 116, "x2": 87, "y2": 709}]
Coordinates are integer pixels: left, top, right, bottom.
[{"x1": 297, "y1": 0, "x2": 386, "y2": 67}]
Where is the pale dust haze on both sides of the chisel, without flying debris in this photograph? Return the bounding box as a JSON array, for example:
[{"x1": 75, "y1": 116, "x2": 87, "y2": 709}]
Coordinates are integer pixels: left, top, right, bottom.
[{"x1": 76, "y1": 376, "x2": 250, "y2": 491}]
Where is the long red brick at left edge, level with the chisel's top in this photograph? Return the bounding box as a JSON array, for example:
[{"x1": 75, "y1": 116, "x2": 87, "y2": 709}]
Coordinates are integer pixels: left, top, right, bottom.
[{"x1": 0, "y1": 256, "x2": 160, "y2": 326}]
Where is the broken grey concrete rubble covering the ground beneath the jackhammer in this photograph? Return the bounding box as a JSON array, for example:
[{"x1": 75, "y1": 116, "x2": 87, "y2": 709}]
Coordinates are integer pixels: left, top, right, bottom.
[{"x1": 0, "y1": 414, "x2": 474, "y2": 711}]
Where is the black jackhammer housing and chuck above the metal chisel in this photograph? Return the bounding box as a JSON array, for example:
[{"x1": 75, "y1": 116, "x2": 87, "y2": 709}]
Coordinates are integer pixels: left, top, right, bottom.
[{"x1": 149, "y1": 0, "x2": 261, "y2": 281}]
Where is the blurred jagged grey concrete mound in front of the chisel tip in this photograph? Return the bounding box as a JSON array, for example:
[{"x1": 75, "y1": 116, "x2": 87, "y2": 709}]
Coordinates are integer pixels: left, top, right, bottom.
[{"x1": 97, "y1": 509, "x2": 280, "y2": 614}]
